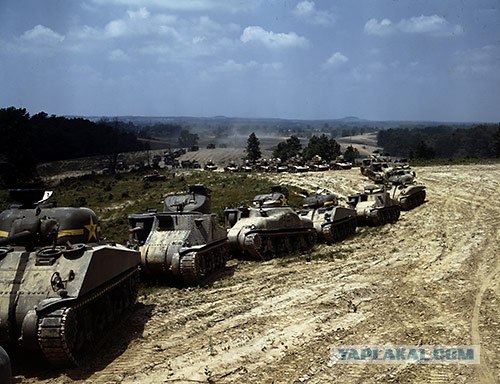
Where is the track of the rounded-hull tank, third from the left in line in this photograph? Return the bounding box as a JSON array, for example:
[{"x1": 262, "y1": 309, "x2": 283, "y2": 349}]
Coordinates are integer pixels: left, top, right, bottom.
[{"x1": 240, "y1": 229, "x2": 316, "y2": 260}]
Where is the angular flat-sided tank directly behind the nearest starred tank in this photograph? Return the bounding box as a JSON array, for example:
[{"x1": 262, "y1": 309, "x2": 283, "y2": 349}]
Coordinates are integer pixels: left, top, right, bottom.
[{"x1": 128, "y1": 185, "x2": 228, "y2": 285}]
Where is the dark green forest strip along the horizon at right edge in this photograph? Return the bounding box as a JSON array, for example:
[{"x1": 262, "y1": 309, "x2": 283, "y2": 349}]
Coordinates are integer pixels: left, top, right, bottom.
[{"x1": 378, "y1": 124, "x2": 500, "y2": 159}]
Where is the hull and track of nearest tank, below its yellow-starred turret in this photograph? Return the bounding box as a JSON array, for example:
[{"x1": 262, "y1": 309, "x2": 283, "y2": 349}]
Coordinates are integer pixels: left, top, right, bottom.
[{"x1": 0, "y1": 244, "x2": 139, "y2": 366}]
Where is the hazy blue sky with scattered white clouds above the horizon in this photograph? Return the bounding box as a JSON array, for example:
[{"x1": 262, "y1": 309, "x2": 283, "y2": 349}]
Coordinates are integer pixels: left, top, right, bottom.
[{"x1": 0, "y1": 0, "x2": 500, "y2": 122}]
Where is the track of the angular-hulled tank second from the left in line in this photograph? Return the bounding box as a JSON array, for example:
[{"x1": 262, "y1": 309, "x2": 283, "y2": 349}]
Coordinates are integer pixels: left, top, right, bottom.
[{"x1": 180, "y1": 243, "x2": 228, "y2": 285}]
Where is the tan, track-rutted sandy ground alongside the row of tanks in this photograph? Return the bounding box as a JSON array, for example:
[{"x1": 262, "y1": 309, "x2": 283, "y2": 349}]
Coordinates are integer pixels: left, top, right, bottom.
[{"x1": 14, "y1": 165, "x2": 500, "y2": 384}]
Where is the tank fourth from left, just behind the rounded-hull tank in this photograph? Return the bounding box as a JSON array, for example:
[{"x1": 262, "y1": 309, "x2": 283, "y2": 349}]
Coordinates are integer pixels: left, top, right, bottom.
[{"x1": 300, "y1": 192, "x2": 356, "y2": 244}]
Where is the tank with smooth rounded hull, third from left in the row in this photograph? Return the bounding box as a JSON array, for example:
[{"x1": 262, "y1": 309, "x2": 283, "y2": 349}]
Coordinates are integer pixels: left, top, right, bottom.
[{"x1": 224, "y1": 186, "x2": 316, "y2": 260}]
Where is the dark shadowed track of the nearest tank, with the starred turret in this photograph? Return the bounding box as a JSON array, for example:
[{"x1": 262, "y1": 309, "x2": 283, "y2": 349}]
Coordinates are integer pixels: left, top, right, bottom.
[{"x1": 37, "y1": 270, "x2": 139, "y2": 367}]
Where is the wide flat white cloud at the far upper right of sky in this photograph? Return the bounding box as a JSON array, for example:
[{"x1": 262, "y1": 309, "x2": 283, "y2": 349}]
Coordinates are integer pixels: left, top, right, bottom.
[{"x1": 364, "y1": 15, "x2": 464, "y2": 36}]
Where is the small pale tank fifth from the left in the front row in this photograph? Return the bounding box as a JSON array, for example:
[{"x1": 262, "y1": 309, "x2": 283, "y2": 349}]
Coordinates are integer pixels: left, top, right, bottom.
[{"x1": 348, "y1": 186, "x2": 401, "y2": 226}]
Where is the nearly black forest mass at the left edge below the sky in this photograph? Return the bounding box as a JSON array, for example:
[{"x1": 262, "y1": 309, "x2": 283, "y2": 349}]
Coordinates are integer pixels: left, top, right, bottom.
[{"x1": 0, "y1": 107, "x2": 145, "y2": 185}]
